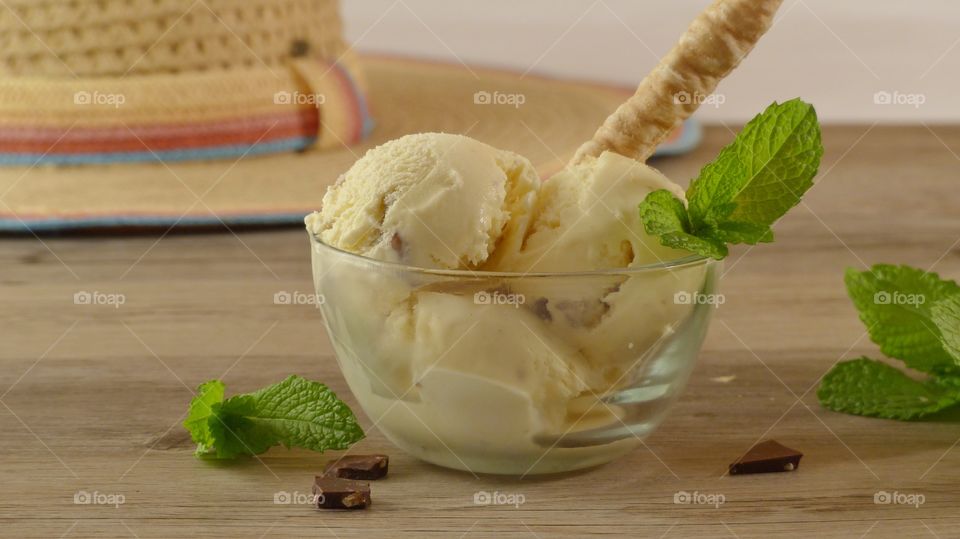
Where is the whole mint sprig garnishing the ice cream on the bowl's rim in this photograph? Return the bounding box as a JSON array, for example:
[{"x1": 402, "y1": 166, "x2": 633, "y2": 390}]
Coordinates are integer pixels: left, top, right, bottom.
[{"x1": 640, "y1": 99, "x2": 823, "y2": 259}]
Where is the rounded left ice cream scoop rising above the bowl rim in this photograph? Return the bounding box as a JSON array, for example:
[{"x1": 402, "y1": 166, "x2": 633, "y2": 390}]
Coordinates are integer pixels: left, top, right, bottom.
[{"x1": 307, "y1": 133, "x2": 540, "y2": 269}]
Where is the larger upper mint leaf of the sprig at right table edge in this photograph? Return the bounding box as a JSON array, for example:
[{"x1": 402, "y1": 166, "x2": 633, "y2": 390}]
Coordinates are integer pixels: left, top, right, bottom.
[{"x1": 844, "y1": 264, "x2": 960, "y2": 374}]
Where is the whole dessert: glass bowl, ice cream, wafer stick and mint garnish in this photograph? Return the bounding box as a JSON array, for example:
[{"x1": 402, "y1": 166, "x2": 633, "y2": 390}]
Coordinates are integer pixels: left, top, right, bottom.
[{"x1": 306, "y1": 0, "x2": 822, "y2": 475}]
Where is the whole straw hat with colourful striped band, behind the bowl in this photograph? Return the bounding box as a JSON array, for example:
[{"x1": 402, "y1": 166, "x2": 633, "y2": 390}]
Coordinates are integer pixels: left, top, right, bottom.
[{"x1": 0, "y1": 0, "x2": 692, "y2": 231}]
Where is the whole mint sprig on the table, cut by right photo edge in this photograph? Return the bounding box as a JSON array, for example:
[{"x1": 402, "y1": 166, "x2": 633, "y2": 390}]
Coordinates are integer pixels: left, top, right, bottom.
[{"x1": 817, "y1": 264, "x2": 960, "y2": 420}]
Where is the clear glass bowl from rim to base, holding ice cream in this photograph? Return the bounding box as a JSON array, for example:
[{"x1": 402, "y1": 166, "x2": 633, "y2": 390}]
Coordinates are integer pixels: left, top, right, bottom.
[{"x1": 310, "y1": 234, "x2": 721, "y2": 475}]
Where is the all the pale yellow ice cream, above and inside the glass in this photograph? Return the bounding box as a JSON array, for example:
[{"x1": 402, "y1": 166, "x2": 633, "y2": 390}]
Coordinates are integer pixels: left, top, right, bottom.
[{"x1": 307, "y1": 134, "x2": 705, "y2": 472}]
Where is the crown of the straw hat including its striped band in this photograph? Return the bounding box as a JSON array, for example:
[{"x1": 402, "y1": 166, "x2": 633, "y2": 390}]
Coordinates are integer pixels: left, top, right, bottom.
[{"x1": 0, "y1": 0, "x2": 366, "y2": 165}]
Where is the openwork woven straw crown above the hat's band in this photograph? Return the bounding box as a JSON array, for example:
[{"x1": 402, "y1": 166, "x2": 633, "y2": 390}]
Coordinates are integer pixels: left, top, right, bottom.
[{"x1": 0, "y1": 0, "x2": 347, "y2": 77}]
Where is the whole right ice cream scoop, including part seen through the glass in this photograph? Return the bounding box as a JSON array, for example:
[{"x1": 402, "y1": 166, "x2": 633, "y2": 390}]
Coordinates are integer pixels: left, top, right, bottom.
[{"x1": 488, "y1": 152, "x2": 703, "y2": 393}]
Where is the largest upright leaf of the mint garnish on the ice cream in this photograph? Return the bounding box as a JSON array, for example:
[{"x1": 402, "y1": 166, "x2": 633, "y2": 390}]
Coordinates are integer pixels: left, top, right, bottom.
[{"x1": 687, "y1": 99, "x2": 823, "y2": 244}]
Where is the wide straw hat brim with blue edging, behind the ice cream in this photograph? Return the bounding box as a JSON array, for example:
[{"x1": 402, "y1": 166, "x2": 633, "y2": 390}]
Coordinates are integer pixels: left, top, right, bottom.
[{"x1": 0, "y1": 57, "x2": 640, "y2": 231}]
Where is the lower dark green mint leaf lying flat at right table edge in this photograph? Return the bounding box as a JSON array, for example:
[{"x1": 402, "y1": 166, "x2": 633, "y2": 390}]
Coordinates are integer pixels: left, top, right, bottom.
[{"x1": 817, "y1": 357, "x2": 960, "y2": 420}]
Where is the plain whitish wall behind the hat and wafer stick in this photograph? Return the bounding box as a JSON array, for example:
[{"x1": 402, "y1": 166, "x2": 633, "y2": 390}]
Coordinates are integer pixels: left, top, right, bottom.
[{"x1": 343, "y1": 0, "x2": 960, "y2": 123}]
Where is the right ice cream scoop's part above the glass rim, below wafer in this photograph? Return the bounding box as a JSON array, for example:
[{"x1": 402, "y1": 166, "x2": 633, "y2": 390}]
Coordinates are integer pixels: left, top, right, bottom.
[{"x1": 487, "y1": 152, "x2": 687, "y2": 272}]
